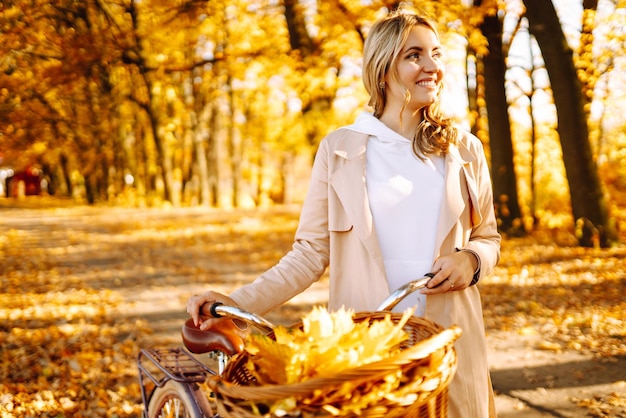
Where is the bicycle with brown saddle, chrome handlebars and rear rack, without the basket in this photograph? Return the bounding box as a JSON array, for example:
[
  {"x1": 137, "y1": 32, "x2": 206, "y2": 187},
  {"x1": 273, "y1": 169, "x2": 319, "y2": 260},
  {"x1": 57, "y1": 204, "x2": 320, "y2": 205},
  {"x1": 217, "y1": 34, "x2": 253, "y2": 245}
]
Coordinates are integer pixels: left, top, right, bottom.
[{"x1": 137, "y1": 273, "x2": 460, "y2": 418}]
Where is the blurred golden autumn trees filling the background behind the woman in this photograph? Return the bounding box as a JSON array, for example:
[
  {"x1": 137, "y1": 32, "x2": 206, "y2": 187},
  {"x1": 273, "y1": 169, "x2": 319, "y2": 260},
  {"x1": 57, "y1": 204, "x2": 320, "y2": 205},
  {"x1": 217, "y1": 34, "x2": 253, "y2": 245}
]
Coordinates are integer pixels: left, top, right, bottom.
[{"x1": 0, "y1": 0, "x2": 626, "y2": 247}]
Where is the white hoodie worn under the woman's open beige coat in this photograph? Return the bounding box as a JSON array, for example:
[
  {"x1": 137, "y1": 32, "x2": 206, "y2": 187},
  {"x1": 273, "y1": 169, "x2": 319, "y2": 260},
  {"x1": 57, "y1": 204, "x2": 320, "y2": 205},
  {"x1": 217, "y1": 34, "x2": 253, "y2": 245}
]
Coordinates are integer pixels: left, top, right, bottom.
[{"x1": 345, "y1": 112, "x2": 445, "y2": 316}]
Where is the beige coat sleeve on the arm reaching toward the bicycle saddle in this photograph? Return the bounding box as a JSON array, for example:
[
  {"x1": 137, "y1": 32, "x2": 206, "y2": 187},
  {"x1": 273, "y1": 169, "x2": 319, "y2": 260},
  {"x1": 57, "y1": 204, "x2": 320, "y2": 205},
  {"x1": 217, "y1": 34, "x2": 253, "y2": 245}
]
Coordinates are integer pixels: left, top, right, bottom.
[{"x1": 225, "y1": 139, "x2": 330, "y2": 315}]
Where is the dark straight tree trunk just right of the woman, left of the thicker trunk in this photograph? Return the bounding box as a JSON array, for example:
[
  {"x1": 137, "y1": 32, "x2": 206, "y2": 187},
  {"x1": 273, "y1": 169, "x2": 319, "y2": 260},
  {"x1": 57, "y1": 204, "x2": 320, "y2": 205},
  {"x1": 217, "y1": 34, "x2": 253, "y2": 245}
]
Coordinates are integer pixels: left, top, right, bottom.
[{"x1": 480, "y1": 15, "x2": 524, "y2": 235}]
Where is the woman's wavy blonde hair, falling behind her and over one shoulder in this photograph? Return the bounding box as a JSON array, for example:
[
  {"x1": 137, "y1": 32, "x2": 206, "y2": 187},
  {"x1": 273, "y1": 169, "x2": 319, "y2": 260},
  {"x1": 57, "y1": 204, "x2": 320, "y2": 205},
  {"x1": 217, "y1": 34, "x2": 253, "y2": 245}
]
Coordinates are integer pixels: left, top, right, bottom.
[{"x1": 363, "y1": 9, "x2": 457, "y2": 158}]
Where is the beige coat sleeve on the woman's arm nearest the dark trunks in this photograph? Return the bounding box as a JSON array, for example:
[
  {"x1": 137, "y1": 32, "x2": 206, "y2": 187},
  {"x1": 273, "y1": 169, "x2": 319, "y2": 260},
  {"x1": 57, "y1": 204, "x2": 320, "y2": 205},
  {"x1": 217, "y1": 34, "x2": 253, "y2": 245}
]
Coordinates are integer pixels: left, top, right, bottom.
[{"x1": 462, "y1": 135, "x2": 501, "y2": 280}]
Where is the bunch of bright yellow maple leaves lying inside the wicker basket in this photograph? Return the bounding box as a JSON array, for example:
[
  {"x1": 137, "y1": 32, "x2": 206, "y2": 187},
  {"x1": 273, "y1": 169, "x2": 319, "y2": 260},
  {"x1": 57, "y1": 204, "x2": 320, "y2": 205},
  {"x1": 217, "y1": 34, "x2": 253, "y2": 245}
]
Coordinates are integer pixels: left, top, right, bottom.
[{"x1": 241, "y1": 307, "x2": 413, "y2": 386}]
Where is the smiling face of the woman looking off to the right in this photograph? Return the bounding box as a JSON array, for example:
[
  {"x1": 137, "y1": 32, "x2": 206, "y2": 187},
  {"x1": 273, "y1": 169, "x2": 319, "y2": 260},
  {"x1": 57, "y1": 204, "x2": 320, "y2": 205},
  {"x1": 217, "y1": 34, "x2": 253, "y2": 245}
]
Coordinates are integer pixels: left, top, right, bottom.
[{"x1": 385, "y1": 25, "x2": 444, "y2": 112}]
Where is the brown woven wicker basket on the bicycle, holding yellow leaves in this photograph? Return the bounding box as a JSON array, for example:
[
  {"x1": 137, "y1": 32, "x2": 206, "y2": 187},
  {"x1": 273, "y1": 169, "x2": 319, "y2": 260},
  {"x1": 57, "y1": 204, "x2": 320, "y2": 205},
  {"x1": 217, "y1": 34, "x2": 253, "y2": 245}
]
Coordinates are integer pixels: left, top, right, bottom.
[{"x1": 207, "y1": 312, "x2": 461, "y2": 418}]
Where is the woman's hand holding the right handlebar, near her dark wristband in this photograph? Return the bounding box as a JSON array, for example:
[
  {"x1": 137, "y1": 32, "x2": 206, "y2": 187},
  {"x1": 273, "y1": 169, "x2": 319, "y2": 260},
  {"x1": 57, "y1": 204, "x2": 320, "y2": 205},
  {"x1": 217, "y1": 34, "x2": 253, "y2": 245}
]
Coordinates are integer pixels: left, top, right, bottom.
[{"x1": 421, "y1": 251, "x2": 478, "y2": 295}]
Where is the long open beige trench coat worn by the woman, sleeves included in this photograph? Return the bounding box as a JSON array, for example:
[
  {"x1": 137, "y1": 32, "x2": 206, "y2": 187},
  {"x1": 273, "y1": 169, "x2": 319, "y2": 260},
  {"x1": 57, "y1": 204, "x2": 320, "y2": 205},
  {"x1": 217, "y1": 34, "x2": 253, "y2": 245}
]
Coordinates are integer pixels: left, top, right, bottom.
[{"x1": 230, "y1": 129, "x2": 500, "y2": 418}]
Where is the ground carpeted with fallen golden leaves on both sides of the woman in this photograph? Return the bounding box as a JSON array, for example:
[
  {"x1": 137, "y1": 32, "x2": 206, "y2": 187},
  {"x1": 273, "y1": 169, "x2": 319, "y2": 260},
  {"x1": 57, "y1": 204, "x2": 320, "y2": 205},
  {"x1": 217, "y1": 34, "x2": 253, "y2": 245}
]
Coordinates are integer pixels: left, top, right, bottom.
[{"x1": 0, "y1": 199, "x2": 626, "y2": 417}]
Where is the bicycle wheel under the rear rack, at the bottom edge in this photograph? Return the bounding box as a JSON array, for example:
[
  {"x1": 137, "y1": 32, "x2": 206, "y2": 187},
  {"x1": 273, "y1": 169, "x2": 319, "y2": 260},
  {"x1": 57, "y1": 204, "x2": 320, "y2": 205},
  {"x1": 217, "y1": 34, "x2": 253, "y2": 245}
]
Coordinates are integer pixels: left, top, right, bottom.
[{"x1": 147, "y1": 380, "x2": 215, "y2": 418}]
